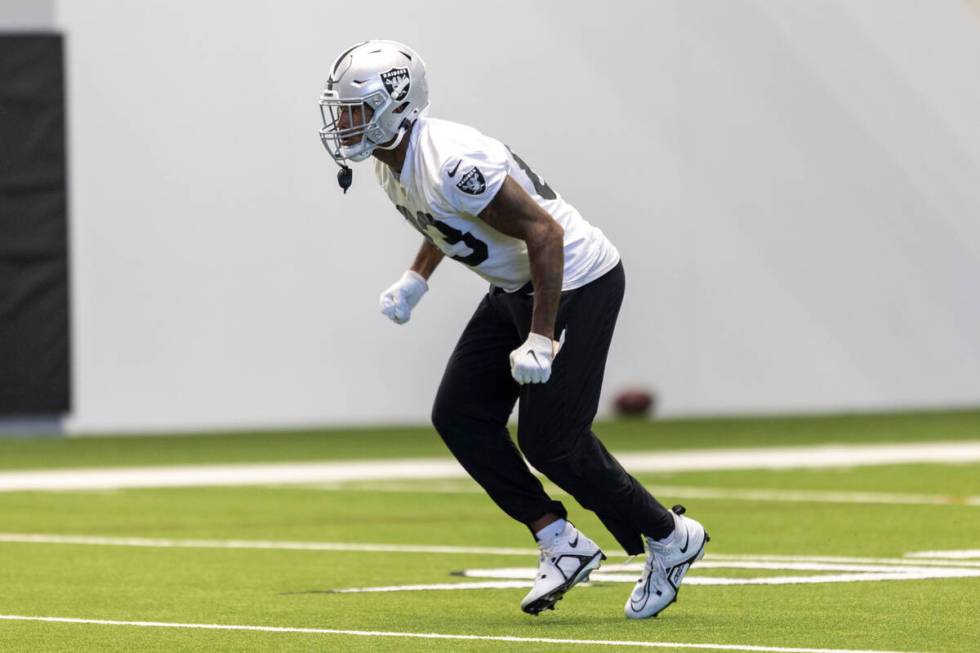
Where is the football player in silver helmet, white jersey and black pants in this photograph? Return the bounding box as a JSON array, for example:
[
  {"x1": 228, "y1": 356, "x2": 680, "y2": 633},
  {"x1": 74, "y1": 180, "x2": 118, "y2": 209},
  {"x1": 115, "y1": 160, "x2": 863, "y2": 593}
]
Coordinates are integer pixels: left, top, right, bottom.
[{"x1": 320, "y1": 41, "x2": 708, "y2": 618}]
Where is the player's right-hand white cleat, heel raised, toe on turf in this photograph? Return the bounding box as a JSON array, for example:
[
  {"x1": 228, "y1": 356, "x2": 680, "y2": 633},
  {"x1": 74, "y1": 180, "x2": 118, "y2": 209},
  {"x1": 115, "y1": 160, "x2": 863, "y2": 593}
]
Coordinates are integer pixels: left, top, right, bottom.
[{"x1": 626, "y1": 505, "x2": 711, "y2": 619}]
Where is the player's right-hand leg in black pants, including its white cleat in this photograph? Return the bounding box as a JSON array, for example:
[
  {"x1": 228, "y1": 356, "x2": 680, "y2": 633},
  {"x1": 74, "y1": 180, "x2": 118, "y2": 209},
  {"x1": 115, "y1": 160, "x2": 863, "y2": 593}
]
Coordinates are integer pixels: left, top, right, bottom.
[{"x1": 518, "y1": 266, "x2": 708, "y2": 618}]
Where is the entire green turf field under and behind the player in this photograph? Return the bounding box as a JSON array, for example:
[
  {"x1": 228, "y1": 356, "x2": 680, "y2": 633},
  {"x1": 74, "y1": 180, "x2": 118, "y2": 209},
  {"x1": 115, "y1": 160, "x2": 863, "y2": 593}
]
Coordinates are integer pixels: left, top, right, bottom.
[{"x1": 0, "y1": 411, "x2": 980, "y2": 653}]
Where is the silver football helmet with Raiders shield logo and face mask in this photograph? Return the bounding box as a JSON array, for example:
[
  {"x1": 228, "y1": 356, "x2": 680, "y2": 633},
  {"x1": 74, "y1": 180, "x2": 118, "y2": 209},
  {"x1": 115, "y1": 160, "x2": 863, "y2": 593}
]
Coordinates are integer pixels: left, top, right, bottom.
[{"x1": 320, "y1": 41, "x2": 429, "y2": 166}]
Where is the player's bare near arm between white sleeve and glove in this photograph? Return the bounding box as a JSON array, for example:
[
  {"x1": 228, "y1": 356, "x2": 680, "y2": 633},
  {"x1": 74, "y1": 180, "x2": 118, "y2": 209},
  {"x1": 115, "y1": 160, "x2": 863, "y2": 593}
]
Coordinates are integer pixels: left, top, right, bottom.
[{"x1": 479, "y1": 176, "x2": 565, "y2": 340}]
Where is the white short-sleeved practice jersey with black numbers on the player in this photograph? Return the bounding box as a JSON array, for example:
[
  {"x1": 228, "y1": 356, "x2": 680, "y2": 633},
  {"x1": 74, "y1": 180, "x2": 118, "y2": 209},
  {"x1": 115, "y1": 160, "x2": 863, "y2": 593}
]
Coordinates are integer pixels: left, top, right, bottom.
[{"x1": 375, "y1": 117, "x2": 619, "y2": 292}]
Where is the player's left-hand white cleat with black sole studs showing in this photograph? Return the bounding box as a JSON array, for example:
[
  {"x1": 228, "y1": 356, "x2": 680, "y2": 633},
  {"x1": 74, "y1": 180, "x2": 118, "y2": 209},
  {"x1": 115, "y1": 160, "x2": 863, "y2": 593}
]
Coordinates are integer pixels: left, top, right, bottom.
[{"x1": 521, "y1": 523, "x2": 606, "y2": 616}]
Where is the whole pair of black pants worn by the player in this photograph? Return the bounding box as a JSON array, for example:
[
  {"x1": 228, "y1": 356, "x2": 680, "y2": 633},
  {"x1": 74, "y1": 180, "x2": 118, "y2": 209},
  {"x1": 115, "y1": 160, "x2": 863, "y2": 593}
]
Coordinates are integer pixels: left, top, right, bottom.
[{"x1": 432, "y1": 264, "x2": 674, "y2": 555}]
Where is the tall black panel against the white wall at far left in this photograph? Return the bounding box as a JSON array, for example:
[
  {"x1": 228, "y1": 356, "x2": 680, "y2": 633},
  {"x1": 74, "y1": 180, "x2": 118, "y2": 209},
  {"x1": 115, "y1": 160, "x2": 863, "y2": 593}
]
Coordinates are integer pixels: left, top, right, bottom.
[{"x1": 0, "y1": 34, "x2": 71, "y2": 415}]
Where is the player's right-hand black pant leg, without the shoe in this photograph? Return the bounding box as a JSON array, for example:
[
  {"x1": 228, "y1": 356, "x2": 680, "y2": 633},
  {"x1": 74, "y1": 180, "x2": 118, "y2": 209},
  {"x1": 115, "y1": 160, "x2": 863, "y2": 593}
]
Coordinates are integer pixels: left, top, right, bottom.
[{"x1": 515, "y1": 266, "x2": 674, "y2": 554}]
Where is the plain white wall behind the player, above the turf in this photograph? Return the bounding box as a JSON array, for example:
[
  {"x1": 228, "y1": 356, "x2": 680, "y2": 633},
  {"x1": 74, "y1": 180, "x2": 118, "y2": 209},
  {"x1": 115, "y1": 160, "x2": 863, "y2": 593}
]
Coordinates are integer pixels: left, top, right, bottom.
[{"x1": 42, "y1": 0, "x2": 980, "y2": 431}]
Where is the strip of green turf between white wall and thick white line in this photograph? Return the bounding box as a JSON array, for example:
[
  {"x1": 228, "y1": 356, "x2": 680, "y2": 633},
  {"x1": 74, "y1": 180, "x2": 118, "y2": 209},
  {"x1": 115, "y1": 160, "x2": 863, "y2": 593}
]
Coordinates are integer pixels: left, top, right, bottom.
[{"x1": 0, "y1": 409, "x2": 980, "y2": 469}]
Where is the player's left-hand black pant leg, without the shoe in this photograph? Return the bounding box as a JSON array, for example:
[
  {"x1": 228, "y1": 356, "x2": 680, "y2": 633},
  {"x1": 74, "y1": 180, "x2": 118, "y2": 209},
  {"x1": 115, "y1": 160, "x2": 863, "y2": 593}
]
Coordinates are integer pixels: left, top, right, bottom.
[{"x1": 432, "y1": 295, "x2": 566, "y2": 524}]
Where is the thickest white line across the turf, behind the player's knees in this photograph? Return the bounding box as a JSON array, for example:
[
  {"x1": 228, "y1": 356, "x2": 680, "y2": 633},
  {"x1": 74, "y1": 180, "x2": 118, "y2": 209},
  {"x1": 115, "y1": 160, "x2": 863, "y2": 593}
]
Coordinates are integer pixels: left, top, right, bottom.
[{"x1": 0, "y1": 442, "x2": 980, "y2": 492}]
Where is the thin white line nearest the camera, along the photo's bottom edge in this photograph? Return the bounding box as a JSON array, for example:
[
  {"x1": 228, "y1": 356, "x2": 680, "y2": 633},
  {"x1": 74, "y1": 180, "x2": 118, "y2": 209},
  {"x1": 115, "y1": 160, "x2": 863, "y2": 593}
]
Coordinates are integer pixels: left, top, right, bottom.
[{"x1": 0, "y1": 614, "x2": 928, "y2": 653}]
